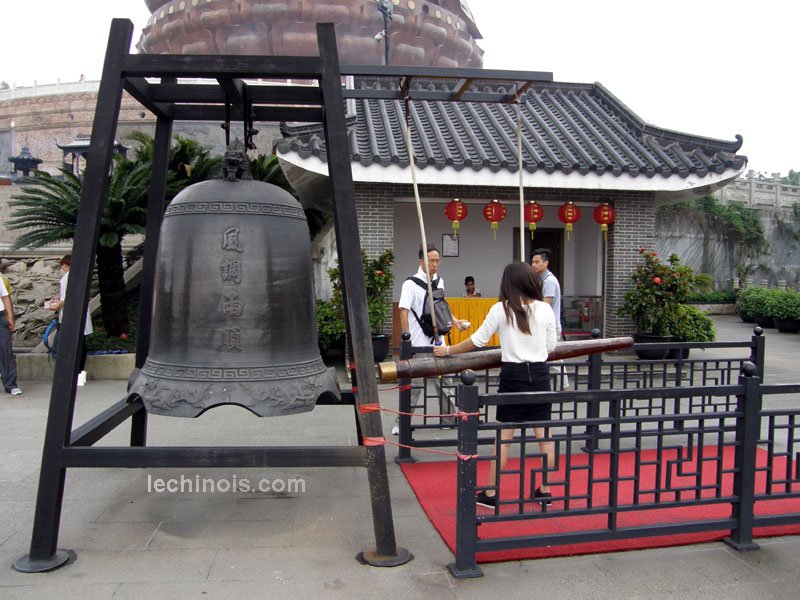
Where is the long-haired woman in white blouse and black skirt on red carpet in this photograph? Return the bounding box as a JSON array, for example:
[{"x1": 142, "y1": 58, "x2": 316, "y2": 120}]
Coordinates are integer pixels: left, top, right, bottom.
[{"x1": 433, "y1": 262, "x2": 556, "y2": 507}]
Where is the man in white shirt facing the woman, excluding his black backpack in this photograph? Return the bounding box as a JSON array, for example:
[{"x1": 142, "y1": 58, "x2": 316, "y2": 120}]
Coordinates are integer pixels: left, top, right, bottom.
[{"x1": 392, "y1": 244, "x2": 469, "y2": 435}]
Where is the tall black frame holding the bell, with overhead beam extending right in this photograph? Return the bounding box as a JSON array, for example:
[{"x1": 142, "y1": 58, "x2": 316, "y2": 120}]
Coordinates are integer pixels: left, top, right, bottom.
[{"x1": 14, "y1": 19, "x2": 553, "y2": 573}]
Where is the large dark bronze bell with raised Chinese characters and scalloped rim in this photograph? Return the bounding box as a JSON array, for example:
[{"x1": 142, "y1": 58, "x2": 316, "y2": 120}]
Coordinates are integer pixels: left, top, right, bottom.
[{"x1": 131, "y1": 149, "x2": 339, "y2": 417}]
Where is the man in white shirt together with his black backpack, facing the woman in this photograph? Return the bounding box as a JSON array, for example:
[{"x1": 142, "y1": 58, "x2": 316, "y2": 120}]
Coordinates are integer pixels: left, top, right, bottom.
[{"x1": 392, "y1": 244, "x2": 469, "y2": 435}]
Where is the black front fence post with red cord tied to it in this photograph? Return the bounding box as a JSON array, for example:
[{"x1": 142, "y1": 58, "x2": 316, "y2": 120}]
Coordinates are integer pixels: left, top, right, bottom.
[{"x1": 447, "y1": 369, "x2": 483, "y2": 579}]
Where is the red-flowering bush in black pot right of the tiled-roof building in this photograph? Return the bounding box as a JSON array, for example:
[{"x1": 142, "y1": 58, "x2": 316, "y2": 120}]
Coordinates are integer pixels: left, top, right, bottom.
[{"x1": 619, "y1": 248, "x2": 696, "y2": 336}]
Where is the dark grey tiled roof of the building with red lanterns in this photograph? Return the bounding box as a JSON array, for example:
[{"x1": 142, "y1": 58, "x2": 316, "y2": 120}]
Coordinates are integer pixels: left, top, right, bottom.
[{"x1": 277, "y1": 82, "x2": 747, "y2": 178}]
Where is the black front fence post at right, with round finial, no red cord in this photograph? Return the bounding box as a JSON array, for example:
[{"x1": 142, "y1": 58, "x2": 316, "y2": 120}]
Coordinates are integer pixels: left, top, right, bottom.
[{"x1": 723, "y1": 362, "x2": 761, "y2": 552}]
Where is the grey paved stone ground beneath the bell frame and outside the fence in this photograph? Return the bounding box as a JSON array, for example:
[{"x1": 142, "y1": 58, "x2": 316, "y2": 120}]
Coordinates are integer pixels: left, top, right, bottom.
[{"x1": 0, "y1": 316, "x2": 800, "y2": 600}]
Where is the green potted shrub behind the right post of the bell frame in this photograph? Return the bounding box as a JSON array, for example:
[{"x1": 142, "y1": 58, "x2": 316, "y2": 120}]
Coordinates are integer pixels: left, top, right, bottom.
[{"x1": 317, "y1": 249, "x2": 394, "y2": 362}]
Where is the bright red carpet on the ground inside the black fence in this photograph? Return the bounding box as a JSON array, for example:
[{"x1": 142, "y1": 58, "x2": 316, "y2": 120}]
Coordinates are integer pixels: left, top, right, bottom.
[{"x1": 401, "y1": 447, "x2": 800, "y2": 563}]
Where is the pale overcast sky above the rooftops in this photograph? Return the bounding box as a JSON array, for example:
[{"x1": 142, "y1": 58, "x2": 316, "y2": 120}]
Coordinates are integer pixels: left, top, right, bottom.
[{"x1": 0, "y1": 0, "x2": 800, "y2": 174}]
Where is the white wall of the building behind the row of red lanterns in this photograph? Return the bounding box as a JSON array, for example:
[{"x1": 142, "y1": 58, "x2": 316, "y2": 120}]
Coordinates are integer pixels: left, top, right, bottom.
[{"x1": 394, "y1": 198, "x2": 613, "y2": 301}]
